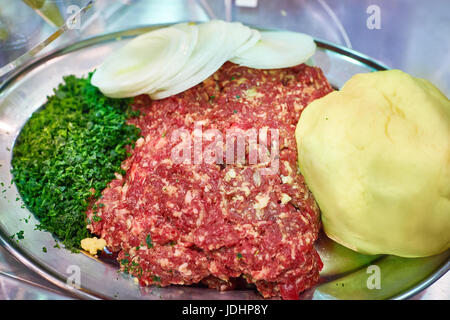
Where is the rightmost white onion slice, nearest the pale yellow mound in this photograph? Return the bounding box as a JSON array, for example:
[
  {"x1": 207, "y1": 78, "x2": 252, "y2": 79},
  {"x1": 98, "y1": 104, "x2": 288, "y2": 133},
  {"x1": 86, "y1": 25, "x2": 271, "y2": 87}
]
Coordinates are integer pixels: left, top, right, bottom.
[{"x1": 230, "y1": 31, "x2": 316, "y2": 69}]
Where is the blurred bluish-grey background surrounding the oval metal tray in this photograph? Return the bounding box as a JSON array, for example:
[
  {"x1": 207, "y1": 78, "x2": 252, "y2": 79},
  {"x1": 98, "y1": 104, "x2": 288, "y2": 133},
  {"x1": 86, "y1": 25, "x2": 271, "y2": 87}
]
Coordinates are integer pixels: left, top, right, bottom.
[{"x1": 0, "y1": 0, "x2": 450, "y2": 299}]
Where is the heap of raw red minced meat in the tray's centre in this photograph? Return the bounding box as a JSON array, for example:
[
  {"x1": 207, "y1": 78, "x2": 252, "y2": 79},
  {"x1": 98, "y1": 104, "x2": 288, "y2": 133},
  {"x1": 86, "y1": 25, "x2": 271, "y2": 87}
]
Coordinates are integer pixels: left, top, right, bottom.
[{"x1": 88, "y1": 63, "x2": 332, "y2": 299}]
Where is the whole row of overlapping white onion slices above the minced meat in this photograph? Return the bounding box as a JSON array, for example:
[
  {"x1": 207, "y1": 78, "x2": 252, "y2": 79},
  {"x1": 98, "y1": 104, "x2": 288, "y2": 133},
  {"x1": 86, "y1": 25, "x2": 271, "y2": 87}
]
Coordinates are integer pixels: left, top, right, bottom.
[{"x1": 91, "y1": 20, "x2": 316, "y2": 99}]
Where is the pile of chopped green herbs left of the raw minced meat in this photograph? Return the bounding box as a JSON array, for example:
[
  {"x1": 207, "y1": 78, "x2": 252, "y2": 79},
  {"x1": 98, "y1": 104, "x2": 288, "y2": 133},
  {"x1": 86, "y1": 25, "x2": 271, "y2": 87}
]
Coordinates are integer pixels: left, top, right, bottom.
[{"x1": 12, "y1": 74, "x2": 140, "y2": 250}]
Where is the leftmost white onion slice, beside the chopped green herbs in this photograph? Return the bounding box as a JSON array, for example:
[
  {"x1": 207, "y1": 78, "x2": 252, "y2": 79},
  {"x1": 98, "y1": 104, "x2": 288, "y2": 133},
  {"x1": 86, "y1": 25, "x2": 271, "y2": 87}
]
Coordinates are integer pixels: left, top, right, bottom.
[{"x1": 91, "y1": 27, "x2": 195, "y2": 98}]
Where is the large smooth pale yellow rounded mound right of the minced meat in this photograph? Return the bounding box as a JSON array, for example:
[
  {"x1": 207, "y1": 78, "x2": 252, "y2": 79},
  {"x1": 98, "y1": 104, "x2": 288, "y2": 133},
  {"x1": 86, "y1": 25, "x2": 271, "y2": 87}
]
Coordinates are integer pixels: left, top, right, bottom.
[{"x1": 296, "y1": 70, "x2": 450, "y2": 257}]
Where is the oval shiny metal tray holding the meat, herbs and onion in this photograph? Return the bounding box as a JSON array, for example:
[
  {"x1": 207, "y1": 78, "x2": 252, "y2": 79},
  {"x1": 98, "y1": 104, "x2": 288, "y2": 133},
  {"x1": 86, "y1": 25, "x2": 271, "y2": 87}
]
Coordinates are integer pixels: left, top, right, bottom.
[{"x1": 0, "y1": 26, "x2": 450, "y2": 299}]
